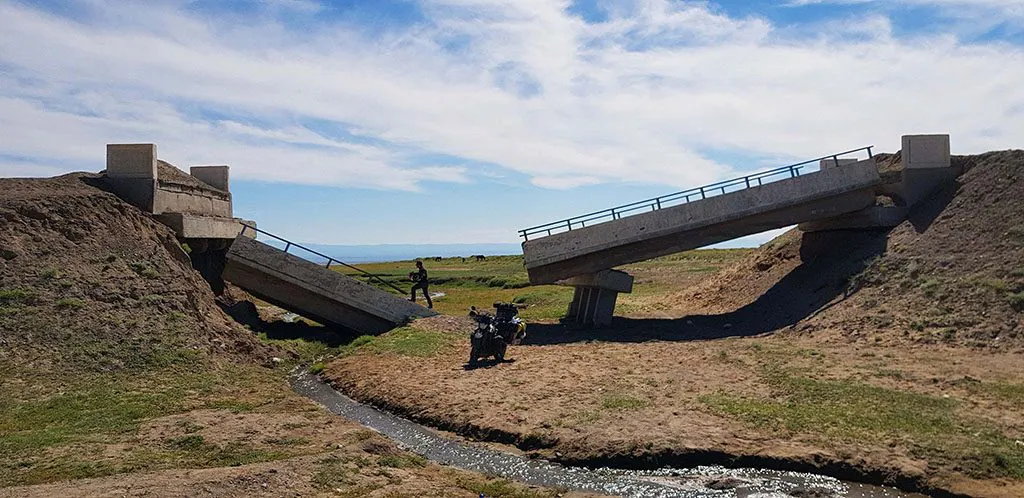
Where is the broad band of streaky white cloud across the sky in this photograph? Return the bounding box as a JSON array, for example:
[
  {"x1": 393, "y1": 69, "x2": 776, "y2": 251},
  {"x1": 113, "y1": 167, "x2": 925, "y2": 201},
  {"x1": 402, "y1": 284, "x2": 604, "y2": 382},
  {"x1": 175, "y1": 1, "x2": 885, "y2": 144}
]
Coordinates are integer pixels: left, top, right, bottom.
[{"x1": 0, "y1": 0, "x2": 1024, "y2": 190}]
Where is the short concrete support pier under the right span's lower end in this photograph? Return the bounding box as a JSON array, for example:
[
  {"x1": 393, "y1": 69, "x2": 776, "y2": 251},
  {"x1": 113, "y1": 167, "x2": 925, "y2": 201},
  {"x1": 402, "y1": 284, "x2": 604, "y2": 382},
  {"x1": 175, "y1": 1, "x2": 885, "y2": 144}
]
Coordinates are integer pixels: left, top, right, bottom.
[{"x1": 564, "y1": 269, "x2": 633, "y2": 326}]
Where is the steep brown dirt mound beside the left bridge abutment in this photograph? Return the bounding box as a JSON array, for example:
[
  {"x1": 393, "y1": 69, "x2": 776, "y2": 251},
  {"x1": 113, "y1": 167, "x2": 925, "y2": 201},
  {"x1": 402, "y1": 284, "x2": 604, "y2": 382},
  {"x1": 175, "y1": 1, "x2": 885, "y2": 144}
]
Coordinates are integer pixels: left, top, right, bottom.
[{"x1": 0, "y1": 174, "x2": 269, "y2": 371}]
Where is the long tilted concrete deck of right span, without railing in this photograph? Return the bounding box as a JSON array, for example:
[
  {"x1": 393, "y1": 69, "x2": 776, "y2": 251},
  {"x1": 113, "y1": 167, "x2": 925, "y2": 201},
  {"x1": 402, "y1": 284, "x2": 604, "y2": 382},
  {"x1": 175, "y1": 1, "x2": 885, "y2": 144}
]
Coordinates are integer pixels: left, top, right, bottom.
[{"x1": 522, "y1": 159, "x2": 881, "y2": 284}]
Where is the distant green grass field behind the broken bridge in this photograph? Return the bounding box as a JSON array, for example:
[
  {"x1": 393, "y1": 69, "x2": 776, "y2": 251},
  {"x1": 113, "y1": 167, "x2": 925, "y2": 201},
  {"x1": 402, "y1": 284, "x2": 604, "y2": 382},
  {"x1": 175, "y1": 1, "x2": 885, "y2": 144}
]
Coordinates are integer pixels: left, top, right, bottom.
[{"x1": 332, "y1": 249, "x2": 751, "y2": 320}]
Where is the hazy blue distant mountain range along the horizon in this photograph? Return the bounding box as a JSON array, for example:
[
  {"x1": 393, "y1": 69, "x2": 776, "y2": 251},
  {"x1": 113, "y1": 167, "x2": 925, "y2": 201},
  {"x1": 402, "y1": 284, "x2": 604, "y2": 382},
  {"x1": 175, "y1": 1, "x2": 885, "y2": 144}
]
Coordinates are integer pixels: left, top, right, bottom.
[{"x1": 260, "y1": 237, "x2": 522, "y2": 263}]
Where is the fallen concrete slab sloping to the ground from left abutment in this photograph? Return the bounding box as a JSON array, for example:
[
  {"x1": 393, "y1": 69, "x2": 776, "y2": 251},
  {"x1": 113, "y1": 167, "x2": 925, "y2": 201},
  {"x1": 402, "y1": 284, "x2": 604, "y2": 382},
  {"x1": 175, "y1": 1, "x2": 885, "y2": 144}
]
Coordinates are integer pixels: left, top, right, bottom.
[{"x1": 223, "y1": 236, "x2": 436, "y2": 334}]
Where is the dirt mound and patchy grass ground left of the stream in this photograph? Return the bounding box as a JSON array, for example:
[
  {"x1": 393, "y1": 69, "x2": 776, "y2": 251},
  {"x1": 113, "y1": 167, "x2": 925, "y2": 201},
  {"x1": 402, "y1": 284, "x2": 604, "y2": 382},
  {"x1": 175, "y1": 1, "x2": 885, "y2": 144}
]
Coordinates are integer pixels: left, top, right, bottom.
[{"x1": 0, "y1": 172, "x2": 577, "y2": 498}]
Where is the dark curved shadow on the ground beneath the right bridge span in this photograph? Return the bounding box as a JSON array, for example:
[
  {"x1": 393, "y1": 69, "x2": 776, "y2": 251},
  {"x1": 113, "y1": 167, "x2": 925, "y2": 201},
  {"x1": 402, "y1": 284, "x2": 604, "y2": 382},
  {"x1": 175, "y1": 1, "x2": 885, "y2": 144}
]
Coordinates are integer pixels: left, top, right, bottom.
[{"x1": 523, "y1": 230, "x2": 889, "y2": 345}]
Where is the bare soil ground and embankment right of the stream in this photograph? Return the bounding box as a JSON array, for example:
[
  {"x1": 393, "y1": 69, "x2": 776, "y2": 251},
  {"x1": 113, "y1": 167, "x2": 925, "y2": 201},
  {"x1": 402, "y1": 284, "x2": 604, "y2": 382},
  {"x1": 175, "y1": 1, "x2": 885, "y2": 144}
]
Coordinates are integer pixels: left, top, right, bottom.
[{"x1": 325, "y1": 151, "x2": 1024, "y2": 497}]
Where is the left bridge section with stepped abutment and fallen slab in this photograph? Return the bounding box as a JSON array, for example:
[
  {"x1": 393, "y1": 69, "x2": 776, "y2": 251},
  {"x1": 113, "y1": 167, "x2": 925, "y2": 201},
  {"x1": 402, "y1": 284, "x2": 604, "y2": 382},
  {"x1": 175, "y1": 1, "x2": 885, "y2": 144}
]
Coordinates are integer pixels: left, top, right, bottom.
[{"x1": 104, "y1": 143, "x2": 435, "y2": 334}]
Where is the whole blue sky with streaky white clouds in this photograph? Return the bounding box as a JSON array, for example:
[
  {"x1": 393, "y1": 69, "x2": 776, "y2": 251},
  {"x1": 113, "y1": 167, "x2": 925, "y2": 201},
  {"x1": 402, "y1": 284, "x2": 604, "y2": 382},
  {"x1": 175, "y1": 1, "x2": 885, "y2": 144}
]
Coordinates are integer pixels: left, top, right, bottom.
[{"x1": 0, "y1": 0, "x2": 1024, "y2": 244}]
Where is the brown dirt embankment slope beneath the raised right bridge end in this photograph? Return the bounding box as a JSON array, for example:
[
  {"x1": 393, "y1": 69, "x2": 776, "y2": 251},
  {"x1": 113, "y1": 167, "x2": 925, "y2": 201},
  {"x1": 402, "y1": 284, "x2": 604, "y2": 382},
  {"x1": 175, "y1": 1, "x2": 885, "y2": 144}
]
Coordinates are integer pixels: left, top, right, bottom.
[{"x1": 672, "y1": 151, "x2": 1024, "y2": 348}]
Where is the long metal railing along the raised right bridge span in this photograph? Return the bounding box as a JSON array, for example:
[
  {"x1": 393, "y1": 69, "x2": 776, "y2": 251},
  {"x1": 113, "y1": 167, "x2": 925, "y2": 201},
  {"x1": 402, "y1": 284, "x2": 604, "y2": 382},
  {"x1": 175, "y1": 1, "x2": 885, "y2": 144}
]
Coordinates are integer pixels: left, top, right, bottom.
[{"x1": 519, "y1": 146, "x2": 874, "y2": 241}]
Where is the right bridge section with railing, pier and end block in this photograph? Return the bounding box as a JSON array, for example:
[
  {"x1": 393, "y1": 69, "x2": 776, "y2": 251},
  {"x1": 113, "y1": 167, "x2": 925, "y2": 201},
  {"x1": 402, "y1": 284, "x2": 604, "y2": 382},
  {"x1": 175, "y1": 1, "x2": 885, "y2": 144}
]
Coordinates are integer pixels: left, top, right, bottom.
[{"x1": 520, "y1": 135, "x2": 955, "y2": 325}]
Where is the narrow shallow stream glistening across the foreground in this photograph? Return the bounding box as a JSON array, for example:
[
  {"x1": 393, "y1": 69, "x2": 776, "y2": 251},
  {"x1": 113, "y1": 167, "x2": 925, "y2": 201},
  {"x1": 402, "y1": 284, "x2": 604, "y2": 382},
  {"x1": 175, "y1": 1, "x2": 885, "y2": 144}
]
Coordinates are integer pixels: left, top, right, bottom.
[{"x1": 291, "y1": 373, "x2": 924, "y2": 498}]
